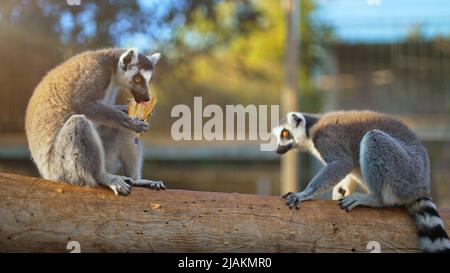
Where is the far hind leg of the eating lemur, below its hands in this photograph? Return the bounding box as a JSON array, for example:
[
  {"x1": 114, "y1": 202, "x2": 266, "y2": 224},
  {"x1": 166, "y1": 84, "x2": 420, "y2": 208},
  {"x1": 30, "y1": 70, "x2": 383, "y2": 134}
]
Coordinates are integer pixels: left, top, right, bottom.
[{"x1": 119, "y1": 132, "x2": 166, "y2": 190}]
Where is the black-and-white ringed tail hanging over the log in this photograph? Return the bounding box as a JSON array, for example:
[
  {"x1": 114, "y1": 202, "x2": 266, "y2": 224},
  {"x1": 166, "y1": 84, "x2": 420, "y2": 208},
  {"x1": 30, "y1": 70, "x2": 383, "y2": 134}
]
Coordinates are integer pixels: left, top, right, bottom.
[{"x1": 407, "y1": 197, "x2": 450, "y2": 253}]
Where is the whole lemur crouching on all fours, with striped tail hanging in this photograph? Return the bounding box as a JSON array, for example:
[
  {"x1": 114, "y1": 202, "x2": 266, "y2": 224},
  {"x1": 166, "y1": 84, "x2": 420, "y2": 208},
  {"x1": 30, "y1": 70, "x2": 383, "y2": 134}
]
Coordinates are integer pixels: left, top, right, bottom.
[{"x1": 273, "y1": 111, "x2": 450, "y2": 252}]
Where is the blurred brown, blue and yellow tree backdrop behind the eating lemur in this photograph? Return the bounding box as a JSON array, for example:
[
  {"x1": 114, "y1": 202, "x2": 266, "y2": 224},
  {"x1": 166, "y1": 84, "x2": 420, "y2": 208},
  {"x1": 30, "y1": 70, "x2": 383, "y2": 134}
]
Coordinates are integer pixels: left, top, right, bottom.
[{"x1": 0, "y1": 0, "x2": 327, "y2": 132}]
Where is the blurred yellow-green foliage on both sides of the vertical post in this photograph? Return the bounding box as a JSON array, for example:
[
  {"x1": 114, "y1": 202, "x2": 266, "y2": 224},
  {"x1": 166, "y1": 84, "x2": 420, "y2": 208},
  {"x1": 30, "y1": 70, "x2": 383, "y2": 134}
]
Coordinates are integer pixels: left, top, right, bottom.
[{"x1": 159, "y1": 1, "x2": 330, "y2": 112}]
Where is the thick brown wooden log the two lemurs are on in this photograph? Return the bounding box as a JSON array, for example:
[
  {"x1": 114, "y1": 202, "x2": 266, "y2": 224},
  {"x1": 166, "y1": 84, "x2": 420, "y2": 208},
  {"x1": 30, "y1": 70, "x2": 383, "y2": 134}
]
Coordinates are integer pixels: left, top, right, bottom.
[{"x1": 0, "y1": 174, "x2": 450, "y2": 252}]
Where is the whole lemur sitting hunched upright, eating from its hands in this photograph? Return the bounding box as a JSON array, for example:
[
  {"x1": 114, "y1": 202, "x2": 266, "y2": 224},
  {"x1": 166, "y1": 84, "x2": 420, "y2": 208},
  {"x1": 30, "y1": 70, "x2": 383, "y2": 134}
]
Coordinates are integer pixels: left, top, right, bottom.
[{"x1": 25, "y1": 48, "x2": 165, "y2": 195}]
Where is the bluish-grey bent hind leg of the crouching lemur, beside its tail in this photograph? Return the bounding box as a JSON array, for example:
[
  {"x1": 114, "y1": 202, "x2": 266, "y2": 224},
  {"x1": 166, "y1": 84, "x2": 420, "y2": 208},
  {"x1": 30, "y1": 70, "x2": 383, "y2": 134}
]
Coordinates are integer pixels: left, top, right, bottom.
[{"x1": 340, "y1": 130, "x2": 423, "y2": 210}]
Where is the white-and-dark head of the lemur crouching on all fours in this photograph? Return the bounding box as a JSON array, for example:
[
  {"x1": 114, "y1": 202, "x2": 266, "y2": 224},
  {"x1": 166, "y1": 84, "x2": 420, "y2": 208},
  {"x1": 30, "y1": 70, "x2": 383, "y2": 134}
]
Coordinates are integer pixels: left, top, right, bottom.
[{"x1": 272, "y1": 112, "x2": 306, "y2": 154}]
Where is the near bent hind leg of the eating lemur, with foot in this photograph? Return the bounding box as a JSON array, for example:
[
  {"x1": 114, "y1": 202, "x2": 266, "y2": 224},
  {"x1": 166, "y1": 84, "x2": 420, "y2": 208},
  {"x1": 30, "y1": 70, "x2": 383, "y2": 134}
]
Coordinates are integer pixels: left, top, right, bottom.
[{"x1": 51, "y1": 115, "x2": 131, "y2": 195}]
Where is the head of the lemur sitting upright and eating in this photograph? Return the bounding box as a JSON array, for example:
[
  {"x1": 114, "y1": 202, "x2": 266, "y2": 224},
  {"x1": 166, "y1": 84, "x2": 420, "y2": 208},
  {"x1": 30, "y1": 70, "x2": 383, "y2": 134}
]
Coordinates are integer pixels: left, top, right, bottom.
[{"x1": 117, "y1": 48, "x2": 161, "y2": 103}]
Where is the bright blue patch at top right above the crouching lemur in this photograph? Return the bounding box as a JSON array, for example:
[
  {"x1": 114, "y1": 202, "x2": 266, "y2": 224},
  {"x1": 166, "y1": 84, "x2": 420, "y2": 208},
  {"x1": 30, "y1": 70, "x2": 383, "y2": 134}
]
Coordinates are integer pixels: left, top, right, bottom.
[{"x1": 314, "y1": 0, "x2": 450, "y2": 42}]
